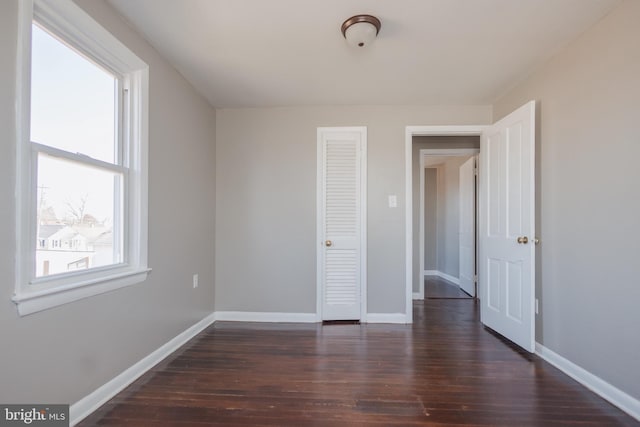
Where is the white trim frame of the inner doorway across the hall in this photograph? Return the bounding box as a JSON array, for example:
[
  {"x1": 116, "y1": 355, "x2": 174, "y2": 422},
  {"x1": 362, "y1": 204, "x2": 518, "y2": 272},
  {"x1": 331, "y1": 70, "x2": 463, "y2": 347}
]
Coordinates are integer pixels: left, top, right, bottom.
[{"x1": 411, "y1": 149, "x2": 480, "y2": 300}]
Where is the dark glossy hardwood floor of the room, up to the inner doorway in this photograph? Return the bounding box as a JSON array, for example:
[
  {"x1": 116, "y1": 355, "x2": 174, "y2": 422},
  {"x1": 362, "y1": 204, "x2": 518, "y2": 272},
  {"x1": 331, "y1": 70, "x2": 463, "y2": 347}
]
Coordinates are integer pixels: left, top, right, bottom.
[{"x1": 80, "y1": 299, "x2": 640, "y2": 426}]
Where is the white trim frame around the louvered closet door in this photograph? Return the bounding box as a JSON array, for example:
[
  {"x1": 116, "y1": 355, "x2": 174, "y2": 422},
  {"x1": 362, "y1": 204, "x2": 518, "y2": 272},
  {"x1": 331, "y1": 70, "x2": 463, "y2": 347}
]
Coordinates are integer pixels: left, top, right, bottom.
[{"x1": 316, "y1": 126, "x2": 367, "y2": 323}]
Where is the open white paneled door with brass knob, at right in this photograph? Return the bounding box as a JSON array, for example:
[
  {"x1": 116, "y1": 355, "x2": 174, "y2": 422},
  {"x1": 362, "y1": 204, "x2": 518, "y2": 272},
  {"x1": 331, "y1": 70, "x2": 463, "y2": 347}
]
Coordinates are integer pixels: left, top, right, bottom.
[{"x1": 478, "y1": 101, "x2": 535, "y2": 352}]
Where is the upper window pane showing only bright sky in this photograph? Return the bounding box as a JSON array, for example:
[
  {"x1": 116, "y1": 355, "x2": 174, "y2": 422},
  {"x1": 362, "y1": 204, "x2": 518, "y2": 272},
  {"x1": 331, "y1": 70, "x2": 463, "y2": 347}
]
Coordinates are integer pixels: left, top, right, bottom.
[{"x1": 31, "y1": 24, "x2": 117, "y2": 163}]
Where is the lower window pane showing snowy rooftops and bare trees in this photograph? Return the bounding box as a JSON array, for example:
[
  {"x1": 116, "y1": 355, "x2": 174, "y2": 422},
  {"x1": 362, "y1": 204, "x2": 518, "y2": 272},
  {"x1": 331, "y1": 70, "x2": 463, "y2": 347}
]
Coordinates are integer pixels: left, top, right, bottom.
[{"x1": 36, "y1": 153, "x2": 123, "y2": 277}]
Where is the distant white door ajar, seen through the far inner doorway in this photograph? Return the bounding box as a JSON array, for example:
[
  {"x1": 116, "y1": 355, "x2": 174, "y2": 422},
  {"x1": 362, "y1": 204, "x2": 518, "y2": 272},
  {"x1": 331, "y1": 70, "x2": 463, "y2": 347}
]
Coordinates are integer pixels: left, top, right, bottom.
[{"x1": 458, "y1": 157, "x2": 476, "y2": 297}]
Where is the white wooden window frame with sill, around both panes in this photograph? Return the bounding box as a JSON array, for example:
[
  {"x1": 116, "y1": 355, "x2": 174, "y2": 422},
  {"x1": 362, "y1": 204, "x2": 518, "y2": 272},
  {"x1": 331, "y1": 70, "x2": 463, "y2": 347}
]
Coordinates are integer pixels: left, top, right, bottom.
[{"x1": 12, "y1": 0, "x2": 151, "y2": 316}]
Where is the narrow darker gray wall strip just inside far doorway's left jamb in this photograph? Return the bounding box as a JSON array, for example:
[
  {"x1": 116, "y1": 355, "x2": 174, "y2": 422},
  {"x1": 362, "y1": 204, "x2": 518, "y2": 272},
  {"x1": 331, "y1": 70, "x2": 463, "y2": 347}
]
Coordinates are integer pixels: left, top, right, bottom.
[{"x1": 424, "y1": 168, "x2": 438, "y2": 270}]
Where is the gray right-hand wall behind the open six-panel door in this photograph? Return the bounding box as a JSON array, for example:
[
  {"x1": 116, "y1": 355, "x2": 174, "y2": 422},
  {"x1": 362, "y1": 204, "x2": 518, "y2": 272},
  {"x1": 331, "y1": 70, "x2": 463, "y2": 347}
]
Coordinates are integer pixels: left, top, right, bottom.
[{"x1": 494, "y1": 1, "x2": 640, "y2": 399}]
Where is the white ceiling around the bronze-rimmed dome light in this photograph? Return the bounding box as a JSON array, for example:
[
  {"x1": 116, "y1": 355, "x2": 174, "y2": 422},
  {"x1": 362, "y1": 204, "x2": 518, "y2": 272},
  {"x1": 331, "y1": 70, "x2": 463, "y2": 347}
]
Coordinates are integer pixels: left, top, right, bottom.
[{"x1": 109, "y1": 0, "x2": 620, "y2": 107}]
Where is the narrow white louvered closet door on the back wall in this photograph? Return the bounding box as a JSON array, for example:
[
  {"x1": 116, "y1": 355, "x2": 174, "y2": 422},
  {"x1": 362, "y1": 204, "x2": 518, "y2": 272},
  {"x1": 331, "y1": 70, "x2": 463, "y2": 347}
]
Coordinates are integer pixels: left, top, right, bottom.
[{"x1": 318, "y1": 128, "x2": 367, "y2": 320}]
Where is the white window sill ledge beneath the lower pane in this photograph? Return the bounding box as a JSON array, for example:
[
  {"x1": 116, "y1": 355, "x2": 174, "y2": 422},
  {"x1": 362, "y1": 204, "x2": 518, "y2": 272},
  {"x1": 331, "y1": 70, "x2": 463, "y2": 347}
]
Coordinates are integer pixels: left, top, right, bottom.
[{"x1": 12, "y1": 268, "x2": 151, "y2": 316}]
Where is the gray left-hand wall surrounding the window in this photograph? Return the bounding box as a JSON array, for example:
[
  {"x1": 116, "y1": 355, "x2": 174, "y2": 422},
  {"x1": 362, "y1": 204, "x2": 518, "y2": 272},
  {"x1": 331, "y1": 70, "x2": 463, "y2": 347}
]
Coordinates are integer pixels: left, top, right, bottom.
[{"x1": 0, "y1": 0, "x2": 215, "y2": 403}]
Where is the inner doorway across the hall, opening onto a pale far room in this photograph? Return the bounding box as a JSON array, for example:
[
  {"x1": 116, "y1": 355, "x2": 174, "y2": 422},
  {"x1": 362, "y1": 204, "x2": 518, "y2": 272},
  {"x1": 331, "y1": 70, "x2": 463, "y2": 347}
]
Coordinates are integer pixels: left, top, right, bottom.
[{"x1": 413, "y1": 150, "x2": 480, "y2": 299}]
